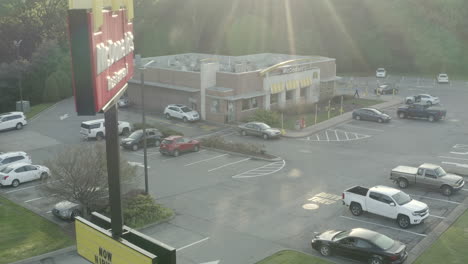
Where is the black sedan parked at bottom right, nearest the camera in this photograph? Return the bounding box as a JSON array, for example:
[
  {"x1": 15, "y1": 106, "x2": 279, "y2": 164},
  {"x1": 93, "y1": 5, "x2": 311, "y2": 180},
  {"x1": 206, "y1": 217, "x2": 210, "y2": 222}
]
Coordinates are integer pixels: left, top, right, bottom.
[{"x1": 312, "y1": 228, "x2": 408, "y2": 264}]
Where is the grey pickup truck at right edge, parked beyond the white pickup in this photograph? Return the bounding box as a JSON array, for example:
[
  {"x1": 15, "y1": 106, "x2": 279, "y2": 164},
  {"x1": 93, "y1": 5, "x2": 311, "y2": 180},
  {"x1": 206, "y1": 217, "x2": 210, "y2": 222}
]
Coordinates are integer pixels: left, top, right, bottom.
[{"x1": 390, "y1": 163, "x2": 465, "y2": 196}]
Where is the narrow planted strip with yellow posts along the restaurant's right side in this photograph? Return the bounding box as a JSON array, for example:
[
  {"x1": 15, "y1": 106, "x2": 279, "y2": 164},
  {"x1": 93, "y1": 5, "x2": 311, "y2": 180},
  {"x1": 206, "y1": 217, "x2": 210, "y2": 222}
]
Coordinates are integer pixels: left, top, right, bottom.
[{"x1": 283, "y1": 98, "x2": 384, "y2": 130}]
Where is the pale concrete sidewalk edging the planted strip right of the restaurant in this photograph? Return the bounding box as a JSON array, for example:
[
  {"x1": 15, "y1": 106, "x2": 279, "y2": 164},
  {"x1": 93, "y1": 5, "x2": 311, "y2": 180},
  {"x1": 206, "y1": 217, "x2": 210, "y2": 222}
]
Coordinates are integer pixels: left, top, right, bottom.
[{"x1": 283, "y1": 98, "x2": 403, "y2": 138}]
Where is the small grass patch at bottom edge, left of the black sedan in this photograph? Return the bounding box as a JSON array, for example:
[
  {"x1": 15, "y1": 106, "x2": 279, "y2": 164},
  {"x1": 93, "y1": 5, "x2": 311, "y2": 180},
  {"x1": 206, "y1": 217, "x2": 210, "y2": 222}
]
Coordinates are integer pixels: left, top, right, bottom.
[{"x1": 257, "y1": 250, "x2": 333, "y2": 264}]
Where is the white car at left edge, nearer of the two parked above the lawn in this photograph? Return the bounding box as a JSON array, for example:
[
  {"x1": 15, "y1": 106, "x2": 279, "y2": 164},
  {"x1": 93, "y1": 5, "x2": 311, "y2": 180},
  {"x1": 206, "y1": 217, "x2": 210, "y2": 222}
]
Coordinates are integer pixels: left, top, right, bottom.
[{"x1": 0, "y1": 163, "x2": 50, "y2": 187}]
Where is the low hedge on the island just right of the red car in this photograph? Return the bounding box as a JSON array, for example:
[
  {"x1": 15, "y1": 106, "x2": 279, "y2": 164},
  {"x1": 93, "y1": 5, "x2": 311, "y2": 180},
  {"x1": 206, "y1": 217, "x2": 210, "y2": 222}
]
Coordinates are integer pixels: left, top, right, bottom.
[{"x1": 200, "y1": 136, "x2": 265, "y2": 155}]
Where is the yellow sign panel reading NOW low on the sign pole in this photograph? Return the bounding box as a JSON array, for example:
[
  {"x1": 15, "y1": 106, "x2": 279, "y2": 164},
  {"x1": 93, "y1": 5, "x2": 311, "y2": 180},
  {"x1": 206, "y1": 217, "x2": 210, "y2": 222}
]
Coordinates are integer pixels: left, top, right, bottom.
[{"x1": 75, "y1": 218, "x2": 156, "y2": 264}]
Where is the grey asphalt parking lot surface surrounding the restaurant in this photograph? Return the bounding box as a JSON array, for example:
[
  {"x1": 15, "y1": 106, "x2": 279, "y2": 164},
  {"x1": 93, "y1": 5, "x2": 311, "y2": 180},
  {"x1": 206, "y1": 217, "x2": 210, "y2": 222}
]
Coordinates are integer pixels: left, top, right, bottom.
[{"x1": 0, "y1": 77, "x2": 468, "y2": 264}]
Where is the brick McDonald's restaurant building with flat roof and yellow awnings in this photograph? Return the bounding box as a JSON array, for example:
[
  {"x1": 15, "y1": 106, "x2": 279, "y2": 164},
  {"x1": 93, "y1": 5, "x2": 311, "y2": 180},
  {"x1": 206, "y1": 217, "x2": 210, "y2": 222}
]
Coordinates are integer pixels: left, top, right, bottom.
[{"x1": 127, "y1": 53, "x2": 339, "y2": 123}]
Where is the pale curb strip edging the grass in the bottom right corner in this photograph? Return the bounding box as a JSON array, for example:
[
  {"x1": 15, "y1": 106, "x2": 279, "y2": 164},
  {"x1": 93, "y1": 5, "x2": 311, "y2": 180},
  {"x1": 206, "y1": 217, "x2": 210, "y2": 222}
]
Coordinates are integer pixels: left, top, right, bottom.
[{"x1": 405, "y1": 197, "x2": 468, "y2": 264}]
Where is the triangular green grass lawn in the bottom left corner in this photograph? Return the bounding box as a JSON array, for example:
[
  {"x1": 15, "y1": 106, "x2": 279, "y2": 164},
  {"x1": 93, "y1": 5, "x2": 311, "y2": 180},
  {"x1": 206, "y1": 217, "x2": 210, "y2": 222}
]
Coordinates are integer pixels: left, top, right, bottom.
[{"x1": 0, "y1": 197, "x2": 74, "y2": 264}]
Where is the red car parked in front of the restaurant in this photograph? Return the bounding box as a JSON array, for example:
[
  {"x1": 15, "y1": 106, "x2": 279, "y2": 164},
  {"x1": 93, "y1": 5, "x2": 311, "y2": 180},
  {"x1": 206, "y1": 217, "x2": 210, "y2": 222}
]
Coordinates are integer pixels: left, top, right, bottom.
[{"x1": 159, "y1": 136, "x2": 200, "y2": 157}]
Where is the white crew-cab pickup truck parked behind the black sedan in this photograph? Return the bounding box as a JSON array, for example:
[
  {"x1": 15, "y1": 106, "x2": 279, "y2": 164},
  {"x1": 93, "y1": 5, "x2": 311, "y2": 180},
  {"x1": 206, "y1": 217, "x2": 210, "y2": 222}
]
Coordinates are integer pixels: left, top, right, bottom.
[{"x1": 342, "y1": 186, "x2": 429, "y2": 228}]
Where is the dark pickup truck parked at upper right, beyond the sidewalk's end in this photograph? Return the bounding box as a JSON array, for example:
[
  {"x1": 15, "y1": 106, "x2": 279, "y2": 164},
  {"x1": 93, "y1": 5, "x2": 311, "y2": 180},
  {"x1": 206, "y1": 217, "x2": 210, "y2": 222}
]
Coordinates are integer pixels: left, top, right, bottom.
[{"x1": 397, "y1": 104, "x2": 447, "y2": 122}]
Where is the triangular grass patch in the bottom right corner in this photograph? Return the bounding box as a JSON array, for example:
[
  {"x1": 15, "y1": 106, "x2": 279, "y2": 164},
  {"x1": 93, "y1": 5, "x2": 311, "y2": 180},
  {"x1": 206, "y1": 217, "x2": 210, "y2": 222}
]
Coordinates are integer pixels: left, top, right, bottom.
[{"x1": 414, "y1": 208, "x2": 468, "y2": 264}]
